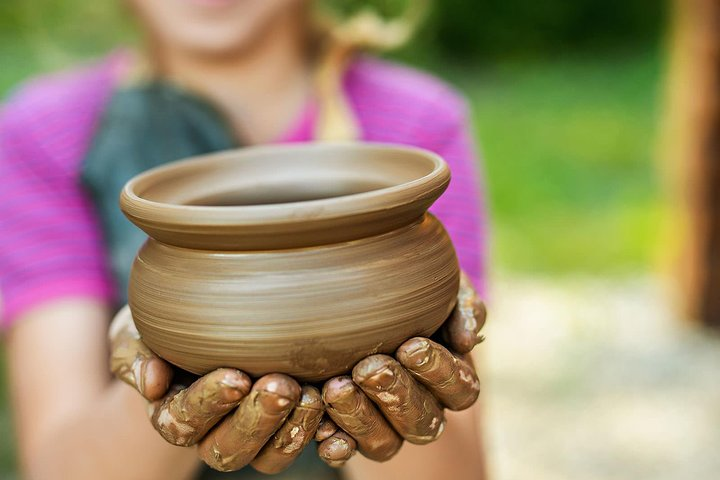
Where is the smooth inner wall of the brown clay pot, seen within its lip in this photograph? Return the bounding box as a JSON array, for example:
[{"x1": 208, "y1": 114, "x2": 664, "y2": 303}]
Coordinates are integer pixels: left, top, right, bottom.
[{"x1": 138, "y1": 145, "x2": 437, "y2": 207}]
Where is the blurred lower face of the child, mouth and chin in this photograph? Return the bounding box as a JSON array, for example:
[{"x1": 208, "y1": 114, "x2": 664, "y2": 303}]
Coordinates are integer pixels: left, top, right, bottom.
[{"x1": 126, "y1": 0, "x2": 307, "y2": 55}]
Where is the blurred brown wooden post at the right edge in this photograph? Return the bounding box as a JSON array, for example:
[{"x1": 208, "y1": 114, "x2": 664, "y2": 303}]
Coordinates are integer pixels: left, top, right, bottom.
[{"x1": 663, "y1": 0, "x2": 720, "y2": 328}]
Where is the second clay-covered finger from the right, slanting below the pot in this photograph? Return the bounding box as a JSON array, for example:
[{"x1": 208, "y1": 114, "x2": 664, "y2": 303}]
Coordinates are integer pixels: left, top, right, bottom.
[{"x1": 396, "y1": 337, "x2": 480, "y2": 410}]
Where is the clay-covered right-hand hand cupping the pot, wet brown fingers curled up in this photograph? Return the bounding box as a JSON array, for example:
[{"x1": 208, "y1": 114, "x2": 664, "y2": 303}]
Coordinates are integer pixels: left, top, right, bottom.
[{"x1": 317, "y1": 275, "x2": 486, "y2": 466}]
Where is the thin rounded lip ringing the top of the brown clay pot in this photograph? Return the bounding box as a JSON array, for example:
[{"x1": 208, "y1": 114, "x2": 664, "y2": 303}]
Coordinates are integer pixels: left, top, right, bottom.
[{"x1": 120, "y1": 142, "x2": 450, "y2": 230}]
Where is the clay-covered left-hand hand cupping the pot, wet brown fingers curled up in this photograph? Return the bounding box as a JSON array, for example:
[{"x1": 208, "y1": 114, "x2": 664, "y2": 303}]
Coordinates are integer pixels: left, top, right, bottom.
[{"x1": 110, "y1": 307, "x2": 323, "y2": 473}]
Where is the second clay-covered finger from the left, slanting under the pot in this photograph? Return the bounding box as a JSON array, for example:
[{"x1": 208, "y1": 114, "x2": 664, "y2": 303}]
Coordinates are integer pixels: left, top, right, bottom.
[{"x1": 150, "y1": 368, "x2": 252, "y2": 447}]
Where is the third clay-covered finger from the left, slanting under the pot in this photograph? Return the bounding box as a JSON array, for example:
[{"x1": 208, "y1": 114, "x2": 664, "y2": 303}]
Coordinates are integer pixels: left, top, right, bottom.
[{"x1": 198, "y1": 373, "x2": 300, "y2": 472}]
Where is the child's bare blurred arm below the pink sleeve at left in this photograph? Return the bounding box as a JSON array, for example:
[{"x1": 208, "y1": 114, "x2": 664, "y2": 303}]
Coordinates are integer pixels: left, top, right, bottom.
[{"x1": 7, "y1": 298, "x2": 198, "y2": 480}]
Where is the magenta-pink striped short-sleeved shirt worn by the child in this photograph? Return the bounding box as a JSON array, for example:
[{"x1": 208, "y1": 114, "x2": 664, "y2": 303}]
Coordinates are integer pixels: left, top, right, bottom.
[{"x1": 0, "y1": 56, "x2": 486, "y2": 326}]
